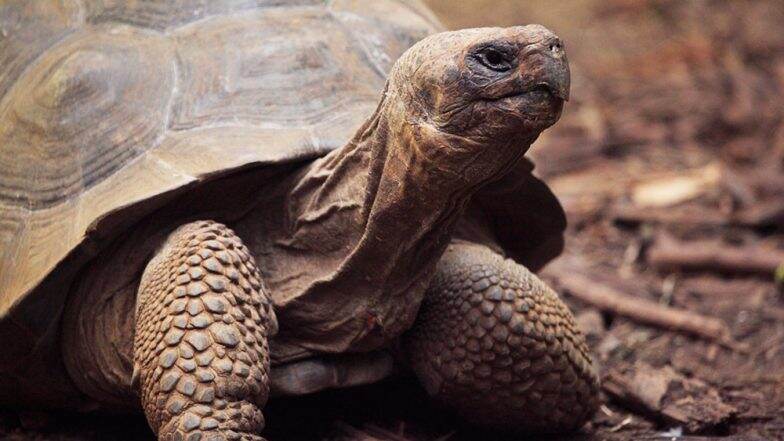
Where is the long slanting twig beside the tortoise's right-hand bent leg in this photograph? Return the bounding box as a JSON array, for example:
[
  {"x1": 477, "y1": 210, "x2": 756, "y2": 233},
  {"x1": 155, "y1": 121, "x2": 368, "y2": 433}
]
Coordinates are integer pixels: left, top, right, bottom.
[{"x1": 545, "y1": 265, "x2": 737, "y2": 347}]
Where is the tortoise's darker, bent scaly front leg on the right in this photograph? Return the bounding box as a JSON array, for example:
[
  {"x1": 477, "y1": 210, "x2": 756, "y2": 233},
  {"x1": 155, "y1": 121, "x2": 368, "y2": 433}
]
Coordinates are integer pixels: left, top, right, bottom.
[{"x1": 404, "y1": 242, "x2": 598, "y2": 432}]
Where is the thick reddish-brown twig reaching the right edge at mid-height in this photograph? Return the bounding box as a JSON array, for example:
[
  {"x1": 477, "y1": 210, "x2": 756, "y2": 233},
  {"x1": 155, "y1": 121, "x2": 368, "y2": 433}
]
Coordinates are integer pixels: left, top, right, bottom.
[{"x1": 648, "y1": 235, "x2": 784, "y2": 276}]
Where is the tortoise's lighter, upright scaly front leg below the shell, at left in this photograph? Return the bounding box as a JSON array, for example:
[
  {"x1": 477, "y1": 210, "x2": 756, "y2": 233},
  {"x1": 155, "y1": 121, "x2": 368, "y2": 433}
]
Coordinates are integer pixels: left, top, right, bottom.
[{"x1": 134, "y1": 221, "x2": 277, "y2": 441}]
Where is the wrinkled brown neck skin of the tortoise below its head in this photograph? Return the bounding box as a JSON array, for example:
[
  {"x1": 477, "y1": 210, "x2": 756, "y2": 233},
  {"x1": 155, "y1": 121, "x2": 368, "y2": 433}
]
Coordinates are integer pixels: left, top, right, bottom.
[{"x1": 260, "y1": 85, "x2": 533, "y2": 363}]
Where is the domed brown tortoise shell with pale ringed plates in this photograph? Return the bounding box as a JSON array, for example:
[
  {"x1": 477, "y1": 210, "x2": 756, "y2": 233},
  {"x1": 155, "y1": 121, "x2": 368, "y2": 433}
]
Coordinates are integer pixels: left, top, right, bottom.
[{"x1": 0, "y1": 0, "x2": 439, "y2": 320}]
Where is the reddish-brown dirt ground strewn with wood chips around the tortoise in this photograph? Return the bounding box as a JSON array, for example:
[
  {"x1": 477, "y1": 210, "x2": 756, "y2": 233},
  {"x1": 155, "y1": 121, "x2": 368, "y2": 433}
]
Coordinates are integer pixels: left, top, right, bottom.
[{"x1": 0, "y1": 0, "x2": 784, "y2": 441}]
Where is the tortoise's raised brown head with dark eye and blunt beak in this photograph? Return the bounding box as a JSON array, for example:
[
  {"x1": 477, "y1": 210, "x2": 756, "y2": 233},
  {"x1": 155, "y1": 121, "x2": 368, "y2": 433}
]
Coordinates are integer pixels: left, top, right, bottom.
[{"x1": 388, "y1": 25, "x2": 569, "y2": 180}]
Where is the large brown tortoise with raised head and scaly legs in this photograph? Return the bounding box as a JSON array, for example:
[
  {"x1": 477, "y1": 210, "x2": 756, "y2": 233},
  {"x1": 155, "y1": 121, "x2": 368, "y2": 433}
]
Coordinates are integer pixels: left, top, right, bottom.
[{"x1": 0, "y1": 0, "x2": 598, "y2": 440}]
